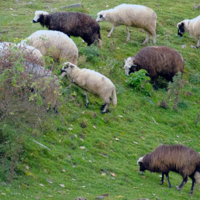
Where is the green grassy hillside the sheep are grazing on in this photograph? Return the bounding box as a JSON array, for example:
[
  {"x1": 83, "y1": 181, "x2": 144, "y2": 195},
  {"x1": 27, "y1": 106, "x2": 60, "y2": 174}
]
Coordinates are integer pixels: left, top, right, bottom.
[{"x1": 0, "y1": 0, "x2": 200, "y2": 200}]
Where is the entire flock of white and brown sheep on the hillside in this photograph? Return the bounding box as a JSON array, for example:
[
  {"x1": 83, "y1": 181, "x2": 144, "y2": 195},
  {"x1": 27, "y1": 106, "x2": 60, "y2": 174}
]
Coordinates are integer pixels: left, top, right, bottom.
[{"x1": 0, "y1": 0, "x2": 200, "y2": 194}]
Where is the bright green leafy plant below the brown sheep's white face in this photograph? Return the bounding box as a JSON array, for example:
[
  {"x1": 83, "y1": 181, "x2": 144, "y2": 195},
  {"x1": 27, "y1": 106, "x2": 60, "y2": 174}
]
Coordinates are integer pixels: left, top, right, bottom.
[{"x1": 127, "y1": 69, "x2": 152, "y2": 96}]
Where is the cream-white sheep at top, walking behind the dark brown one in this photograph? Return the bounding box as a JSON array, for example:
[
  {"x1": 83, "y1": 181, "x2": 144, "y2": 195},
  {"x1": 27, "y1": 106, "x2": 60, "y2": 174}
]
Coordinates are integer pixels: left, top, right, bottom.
[{"x1": 96, "y1": 4, "x2": 157, "y2": 45}]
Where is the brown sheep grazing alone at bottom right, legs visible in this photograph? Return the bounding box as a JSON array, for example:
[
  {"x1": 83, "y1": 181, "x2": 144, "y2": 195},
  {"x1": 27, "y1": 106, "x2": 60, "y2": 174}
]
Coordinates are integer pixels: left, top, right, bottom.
[{"x1": 137, "y1": 145, "x2": 200, "y2": 194}]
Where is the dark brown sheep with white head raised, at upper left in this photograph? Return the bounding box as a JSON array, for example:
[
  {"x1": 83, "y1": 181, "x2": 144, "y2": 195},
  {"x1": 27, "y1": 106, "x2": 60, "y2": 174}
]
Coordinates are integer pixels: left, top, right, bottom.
[{"x1": 33, "y1": 10, "x2": 102, "y2": 49}]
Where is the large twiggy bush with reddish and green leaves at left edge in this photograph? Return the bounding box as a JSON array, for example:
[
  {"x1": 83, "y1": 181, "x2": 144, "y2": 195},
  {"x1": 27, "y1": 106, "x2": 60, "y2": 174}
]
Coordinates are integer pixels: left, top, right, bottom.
[{"x1": 0, "y1": 45, "x2": 59, "y2": 182}]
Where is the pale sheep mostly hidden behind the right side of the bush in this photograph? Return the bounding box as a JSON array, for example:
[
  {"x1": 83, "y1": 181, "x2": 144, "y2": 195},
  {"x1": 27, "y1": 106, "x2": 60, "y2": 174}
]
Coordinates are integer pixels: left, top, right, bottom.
[{"x1": 24, "y1": 62, "x2": 60, "y2": 113}]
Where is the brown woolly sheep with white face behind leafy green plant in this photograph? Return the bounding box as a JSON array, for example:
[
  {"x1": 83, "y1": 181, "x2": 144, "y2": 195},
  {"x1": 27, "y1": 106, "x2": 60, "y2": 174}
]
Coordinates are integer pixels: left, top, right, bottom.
[{"x1": 124, "y1": 46, "x2": 184, "y2": 90}]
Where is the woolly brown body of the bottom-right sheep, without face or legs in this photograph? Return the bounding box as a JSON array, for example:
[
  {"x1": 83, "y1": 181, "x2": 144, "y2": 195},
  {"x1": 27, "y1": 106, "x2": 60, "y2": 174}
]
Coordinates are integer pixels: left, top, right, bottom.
[{"x1": 142, "y1": 145, "x2": 200, "y2": 177}]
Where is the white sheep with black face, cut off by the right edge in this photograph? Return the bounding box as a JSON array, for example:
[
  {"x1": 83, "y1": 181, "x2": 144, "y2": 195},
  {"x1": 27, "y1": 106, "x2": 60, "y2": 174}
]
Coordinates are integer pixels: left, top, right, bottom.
[{"x1": 177, "y1": 15, "x2": 200, "y2": 48}]
